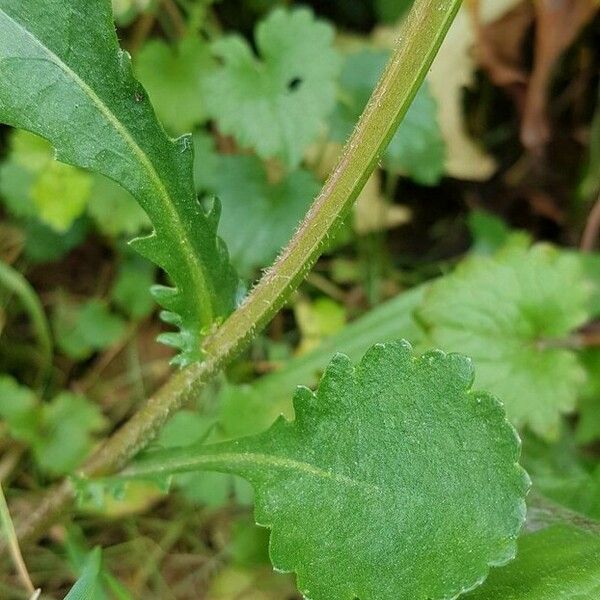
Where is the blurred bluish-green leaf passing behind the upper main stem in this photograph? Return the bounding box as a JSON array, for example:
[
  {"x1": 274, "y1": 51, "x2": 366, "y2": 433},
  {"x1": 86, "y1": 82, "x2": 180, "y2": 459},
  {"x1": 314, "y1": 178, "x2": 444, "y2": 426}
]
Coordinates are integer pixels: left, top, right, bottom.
[{"x1": 331, "y1": 50, "x2": 446, "y2": 185}]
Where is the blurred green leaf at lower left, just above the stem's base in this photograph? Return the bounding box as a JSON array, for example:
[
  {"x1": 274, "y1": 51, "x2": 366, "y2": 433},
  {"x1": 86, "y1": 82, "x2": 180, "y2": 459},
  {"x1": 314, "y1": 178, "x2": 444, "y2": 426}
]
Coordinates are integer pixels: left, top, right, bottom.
[{"x1": 33, "y1": 392, "x2": 105, "y2": 475}]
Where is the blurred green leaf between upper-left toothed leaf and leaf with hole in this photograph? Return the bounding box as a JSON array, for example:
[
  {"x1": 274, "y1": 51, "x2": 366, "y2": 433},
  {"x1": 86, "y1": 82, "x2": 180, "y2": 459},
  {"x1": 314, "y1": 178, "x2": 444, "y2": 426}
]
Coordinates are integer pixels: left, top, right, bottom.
[{"x1": 135, "y1": 36, "x2": 215, "y2": 133}]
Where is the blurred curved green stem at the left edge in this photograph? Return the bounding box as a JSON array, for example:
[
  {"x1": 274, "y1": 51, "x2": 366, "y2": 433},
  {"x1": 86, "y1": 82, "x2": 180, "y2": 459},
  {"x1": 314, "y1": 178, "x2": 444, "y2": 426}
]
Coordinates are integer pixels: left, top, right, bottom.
[{"x1": 0, "y1": 261, "x2": 52, "y2": 378}]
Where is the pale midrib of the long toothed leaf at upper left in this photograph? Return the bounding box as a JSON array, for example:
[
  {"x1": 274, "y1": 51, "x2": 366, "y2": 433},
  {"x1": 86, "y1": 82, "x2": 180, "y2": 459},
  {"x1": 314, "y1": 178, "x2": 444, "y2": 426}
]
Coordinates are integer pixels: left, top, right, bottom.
[{"x1": 0, "y1": 9, "x2": 213, "y2": 324}]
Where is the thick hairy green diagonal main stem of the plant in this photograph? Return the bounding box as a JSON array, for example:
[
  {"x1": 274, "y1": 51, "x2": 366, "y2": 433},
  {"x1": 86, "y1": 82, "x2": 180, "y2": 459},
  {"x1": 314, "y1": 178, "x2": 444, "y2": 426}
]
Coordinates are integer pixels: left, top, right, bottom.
[{"x1": 11, "y1": 0, "x2": 461, "y2": 538}]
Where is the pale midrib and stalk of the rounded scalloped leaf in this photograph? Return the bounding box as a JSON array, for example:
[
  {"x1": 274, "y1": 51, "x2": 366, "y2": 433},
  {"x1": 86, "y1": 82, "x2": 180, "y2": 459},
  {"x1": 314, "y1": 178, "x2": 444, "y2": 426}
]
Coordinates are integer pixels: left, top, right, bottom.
[{"x1": 134, "y1": 452, "x2": 380, "y2": 492}]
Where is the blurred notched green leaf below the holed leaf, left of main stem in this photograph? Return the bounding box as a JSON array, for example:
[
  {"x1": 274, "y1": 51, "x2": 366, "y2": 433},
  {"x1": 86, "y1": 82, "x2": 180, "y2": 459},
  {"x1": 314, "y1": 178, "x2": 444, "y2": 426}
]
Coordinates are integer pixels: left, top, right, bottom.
[{"x1": 214, "y1": 156, "x2": 321, "y2": 275}]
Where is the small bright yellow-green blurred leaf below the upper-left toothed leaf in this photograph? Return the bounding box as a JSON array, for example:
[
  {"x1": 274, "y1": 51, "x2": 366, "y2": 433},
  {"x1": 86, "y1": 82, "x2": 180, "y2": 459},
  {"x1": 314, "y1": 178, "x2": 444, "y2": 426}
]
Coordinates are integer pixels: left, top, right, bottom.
[{"x1": 31, "y1": 161, "x2": 92, "y2": 233}]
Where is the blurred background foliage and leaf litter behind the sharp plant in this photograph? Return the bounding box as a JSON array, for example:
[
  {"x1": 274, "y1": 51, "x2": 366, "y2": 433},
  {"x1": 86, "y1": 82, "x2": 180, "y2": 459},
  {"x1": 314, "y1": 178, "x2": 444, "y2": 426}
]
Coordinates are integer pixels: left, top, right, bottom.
[{"x1": 0, "y1": 0, "x2": 600, "y2": 600}]
